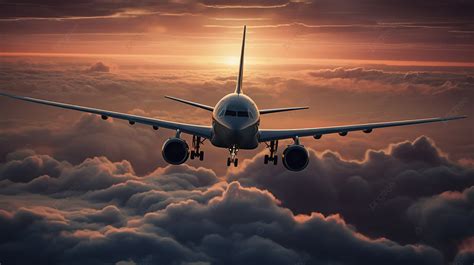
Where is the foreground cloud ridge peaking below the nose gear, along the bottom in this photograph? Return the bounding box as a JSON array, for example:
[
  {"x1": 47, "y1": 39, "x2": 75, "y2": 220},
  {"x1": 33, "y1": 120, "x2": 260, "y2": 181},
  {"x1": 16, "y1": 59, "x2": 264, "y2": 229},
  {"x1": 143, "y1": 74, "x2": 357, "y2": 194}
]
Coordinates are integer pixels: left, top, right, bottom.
[{"x1": 0, "y1": 177, "x2": 442, "y2": 264}]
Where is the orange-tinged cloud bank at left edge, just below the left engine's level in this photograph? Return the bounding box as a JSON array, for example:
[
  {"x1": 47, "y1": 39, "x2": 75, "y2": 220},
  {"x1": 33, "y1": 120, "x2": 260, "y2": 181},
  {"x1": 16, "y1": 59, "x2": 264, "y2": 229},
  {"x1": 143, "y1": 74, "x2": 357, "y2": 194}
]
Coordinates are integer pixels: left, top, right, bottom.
[{"x1": 0, "y1": 148, "x2": 218, "y2": 198}]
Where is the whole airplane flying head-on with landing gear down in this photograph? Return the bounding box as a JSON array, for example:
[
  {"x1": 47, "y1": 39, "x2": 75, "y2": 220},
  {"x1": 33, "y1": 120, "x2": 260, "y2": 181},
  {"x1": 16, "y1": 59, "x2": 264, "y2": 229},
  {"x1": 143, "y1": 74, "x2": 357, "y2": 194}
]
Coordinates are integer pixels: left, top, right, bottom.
[{"x1": 0, "y1": 26, "x2": 466, "y2": 171}]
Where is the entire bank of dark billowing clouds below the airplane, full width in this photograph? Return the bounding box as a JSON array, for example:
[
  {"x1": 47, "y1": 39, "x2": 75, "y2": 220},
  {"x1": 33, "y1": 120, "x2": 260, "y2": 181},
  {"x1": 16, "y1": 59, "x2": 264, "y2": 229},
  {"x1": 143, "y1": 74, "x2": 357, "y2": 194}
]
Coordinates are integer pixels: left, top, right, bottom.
[{"x1": 0, "y1": 137, "x2": 474, "y2": 264}]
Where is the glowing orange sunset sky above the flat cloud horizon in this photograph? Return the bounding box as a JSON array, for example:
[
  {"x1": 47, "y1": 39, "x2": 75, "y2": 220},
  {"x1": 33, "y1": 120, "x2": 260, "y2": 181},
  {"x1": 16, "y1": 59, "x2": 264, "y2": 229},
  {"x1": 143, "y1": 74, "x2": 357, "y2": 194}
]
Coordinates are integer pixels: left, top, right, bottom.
[{"x1": 0, "y1": 0, "x2": 474, "y2": 63}]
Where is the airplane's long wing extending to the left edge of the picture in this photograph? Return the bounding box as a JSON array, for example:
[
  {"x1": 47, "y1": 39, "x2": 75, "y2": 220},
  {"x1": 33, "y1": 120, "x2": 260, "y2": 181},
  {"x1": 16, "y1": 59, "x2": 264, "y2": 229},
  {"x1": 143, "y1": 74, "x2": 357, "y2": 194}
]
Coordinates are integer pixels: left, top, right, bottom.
[{"x1": 0, "y1": 93, "x2": 212, "y2": 139}]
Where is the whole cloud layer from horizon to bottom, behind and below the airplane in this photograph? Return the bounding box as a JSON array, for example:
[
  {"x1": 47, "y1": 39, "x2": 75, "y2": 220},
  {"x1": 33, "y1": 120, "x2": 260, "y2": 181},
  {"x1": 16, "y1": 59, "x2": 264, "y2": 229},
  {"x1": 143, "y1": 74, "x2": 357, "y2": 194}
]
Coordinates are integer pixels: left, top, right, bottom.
[{"x1": 0, "y1": 56, "x2": 474, "y2": 264}]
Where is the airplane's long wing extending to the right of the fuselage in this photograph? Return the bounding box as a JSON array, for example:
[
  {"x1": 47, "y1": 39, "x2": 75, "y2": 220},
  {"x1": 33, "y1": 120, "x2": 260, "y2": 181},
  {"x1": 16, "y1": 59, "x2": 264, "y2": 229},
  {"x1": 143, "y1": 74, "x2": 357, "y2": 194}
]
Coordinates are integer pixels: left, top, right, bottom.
[{"x1": 259, "y1": 116, "x2": 466, "y2": 142}]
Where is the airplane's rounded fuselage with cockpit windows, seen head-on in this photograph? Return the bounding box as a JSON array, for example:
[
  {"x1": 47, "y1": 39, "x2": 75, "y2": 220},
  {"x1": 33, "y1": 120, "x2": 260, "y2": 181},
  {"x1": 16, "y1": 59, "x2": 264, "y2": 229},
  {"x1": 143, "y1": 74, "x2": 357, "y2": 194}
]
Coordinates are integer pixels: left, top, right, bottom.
[{"x1": 210, "y1": 93, "x2": 260, "y2": 149}]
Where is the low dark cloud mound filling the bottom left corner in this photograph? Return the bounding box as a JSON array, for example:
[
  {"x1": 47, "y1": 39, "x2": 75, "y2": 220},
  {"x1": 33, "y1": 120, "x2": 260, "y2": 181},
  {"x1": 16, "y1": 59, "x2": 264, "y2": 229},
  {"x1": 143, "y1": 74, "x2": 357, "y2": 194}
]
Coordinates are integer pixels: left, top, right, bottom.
[{"x1": 0, "y1": 208, "x2": 203, "y2": 264}]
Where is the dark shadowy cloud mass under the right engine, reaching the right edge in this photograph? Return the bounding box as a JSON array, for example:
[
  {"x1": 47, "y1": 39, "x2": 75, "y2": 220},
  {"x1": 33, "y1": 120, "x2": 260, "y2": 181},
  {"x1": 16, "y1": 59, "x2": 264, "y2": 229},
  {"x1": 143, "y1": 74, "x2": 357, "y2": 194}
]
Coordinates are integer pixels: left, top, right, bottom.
[{"x1": 228, "y1": 137, "x2": 474, "y2": 259}]
